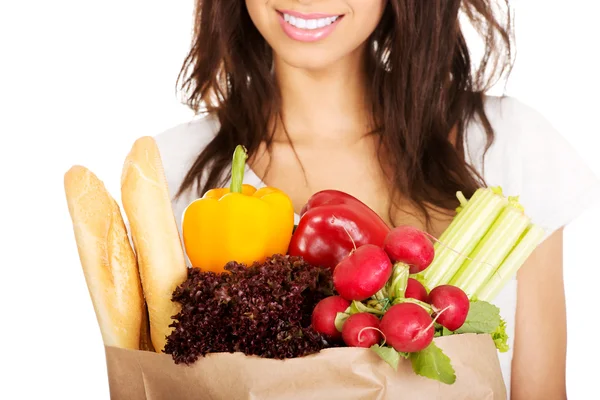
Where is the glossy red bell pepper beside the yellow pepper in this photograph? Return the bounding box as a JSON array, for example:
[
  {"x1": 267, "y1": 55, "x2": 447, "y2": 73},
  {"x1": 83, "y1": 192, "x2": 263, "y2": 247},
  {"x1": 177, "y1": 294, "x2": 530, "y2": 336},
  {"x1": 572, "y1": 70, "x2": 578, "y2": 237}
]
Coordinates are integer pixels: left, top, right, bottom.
[{"x1": 288, "y1": 190, "x2": 390, "y2": 270}]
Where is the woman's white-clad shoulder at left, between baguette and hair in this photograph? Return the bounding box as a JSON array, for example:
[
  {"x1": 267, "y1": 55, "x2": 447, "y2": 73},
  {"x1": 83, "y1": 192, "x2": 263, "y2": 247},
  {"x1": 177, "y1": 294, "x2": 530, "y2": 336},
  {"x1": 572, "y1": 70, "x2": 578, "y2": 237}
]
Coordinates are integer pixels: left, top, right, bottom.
[{"x1": 154, "y1": 115, "x2": 218, "y2": 198}]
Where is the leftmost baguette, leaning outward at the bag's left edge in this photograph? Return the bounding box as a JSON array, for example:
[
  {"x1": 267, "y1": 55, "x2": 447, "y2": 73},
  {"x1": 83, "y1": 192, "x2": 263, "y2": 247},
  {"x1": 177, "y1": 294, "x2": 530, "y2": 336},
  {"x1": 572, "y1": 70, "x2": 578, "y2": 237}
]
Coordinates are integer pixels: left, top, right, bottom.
[{"x1": 64, "y1": 165, "x2": 145, "y2": 350}]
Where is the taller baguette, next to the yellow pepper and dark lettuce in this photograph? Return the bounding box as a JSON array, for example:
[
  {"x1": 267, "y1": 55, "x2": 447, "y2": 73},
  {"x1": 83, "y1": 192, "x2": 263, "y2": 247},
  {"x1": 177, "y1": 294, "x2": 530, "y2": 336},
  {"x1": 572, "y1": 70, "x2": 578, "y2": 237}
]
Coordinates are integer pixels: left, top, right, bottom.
[{"x1": 121, "y1": 136, "x2": 187, "y2": 353}]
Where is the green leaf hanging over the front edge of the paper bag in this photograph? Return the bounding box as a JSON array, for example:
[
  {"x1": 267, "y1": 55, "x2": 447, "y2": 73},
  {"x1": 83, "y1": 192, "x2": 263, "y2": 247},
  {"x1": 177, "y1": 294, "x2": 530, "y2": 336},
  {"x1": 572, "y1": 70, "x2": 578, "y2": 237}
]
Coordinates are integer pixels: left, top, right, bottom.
[{"x1": 410, "y1": 342, "x2": 456, "y2": 385}]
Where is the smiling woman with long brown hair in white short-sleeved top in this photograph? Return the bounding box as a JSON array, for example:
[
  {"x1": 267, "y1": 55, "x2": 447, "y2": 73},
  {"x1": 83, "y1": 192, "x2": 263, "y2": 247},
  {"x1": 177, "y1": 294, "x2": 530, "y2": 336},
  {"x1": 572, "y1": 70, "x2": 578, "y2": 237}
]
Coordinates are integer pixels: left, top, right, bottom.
[{"x1": 157, "y1": 0, "x2": 598, "y2": 400}]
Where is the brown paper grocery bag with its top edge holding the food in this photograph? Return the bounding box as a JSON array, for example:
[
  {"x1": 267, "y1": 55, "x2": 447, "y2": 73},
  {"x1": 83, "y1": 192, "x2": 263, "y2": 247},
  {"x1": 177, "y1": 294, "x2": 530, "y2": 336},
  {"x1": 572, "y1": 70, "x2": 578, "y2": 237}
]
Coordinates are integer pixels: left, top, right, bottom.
[{"x1": 106, "y1": 334, "x2": 506, "y2": 400}]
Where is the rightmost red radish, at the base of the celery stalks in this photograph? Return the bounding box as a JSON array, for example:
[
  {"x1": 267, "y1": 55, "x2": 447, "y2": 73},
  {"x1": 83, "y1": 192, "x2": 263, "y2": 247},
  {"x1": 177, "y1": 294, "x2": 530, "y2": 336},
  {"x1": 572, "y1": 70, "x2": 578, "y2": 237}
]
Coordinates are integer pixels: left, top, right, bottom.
[{"x1": 429, "y1": 285, "x2": 470, "y2": 331}]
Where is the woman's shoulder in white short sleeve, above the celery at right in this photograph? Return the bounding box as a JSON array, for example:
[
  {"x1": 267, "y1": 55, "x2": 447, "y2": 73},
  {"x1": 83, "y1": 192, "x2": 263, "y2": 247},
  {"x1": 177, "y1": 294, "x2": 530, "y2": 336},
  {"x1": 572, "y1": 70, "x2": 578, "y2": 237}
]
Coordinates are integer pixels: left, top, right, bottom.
[{"x1": 465, "y1": 96, "x2": 600, "y2": 234}]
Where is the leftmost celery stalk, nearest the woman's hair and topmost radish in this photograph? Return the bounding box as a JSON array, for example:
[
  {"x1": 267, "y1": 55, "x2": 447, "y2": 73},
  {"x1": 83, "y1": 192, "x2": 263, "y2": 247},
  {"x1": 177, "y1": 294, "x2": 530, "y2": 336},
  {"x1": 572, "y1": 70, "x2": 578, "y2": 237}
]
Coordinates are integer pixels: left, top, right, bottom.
[{"x1": 424, "y1": 189, "x2": 508, "y2": 288}]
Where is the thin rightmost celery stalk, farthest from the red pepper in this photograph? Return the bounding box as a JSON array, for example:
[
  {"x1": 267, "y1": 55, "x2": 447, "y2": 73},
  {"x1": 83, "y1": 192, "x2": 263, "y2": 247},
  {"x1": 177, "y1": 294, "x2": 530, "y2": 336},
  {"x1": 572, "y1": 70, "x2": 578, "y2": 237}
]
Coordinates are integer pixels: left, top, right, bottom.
[{"x1": 475, "y1": 224, "x2": 545, "y2": 302}]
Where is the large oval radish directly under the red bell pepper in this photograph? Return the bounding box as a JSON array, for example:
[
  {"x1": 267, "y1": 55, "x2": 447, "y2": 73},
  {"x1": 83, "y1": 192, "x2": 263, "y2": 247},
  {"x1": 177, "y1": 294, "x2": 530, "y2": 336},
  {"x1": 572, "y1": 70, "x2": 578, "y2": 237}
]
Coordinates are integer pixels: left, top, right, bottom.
[{"x1": 333, "y1": 244, "x2": 392, "y2": 301}]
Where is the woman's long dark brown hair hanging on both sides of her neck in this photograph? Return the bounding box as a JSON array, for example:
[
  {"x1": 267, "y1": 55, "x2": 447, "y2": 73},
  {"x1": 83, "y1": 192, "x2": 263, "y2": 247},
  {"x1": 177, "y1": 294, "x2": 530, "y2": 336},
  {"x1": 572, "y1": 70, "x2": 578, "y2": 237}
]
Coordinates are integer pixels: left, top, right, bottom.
[{"x1": 172, "y1": 0, "x2": 512, "y2": 225}]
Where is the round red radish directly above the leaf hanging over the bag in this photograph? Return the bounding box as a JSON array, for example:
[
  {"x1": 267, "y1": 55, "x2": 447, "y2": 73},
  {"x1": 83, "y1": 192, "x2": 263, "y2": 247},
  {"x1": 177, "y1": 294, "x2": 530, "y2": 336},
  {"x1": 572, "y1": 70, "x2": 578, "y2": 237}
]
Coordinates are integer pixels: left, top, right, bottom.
[{"x1": 379, "y1": 303, "x2": 435, "y2": 353}]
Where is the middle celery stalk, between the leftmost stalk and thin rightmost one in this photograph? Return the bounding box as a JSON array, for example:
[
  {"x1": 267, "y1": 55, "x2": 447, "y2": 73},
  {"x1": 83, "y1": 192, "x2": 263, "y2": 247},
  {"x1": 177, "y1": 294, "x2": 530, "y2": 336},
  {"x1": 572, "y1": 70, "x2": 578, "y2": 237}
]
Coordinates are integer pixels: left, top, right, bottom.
[{"x1": 450, "y1": 204, "x2": 530, "y2": 298}]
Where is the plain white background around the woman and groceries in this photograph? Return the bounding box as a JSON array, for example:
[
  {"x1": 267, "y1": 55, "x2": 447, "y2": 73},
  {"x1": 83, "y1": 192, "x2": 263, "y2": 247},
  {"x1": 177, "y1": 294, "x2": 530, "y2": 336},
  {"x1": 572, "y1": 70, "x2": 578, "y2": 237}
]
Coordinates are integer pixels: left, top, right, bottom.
[{"x1": 0, "y1": 0, "x2": 600, "y2": 399}]
